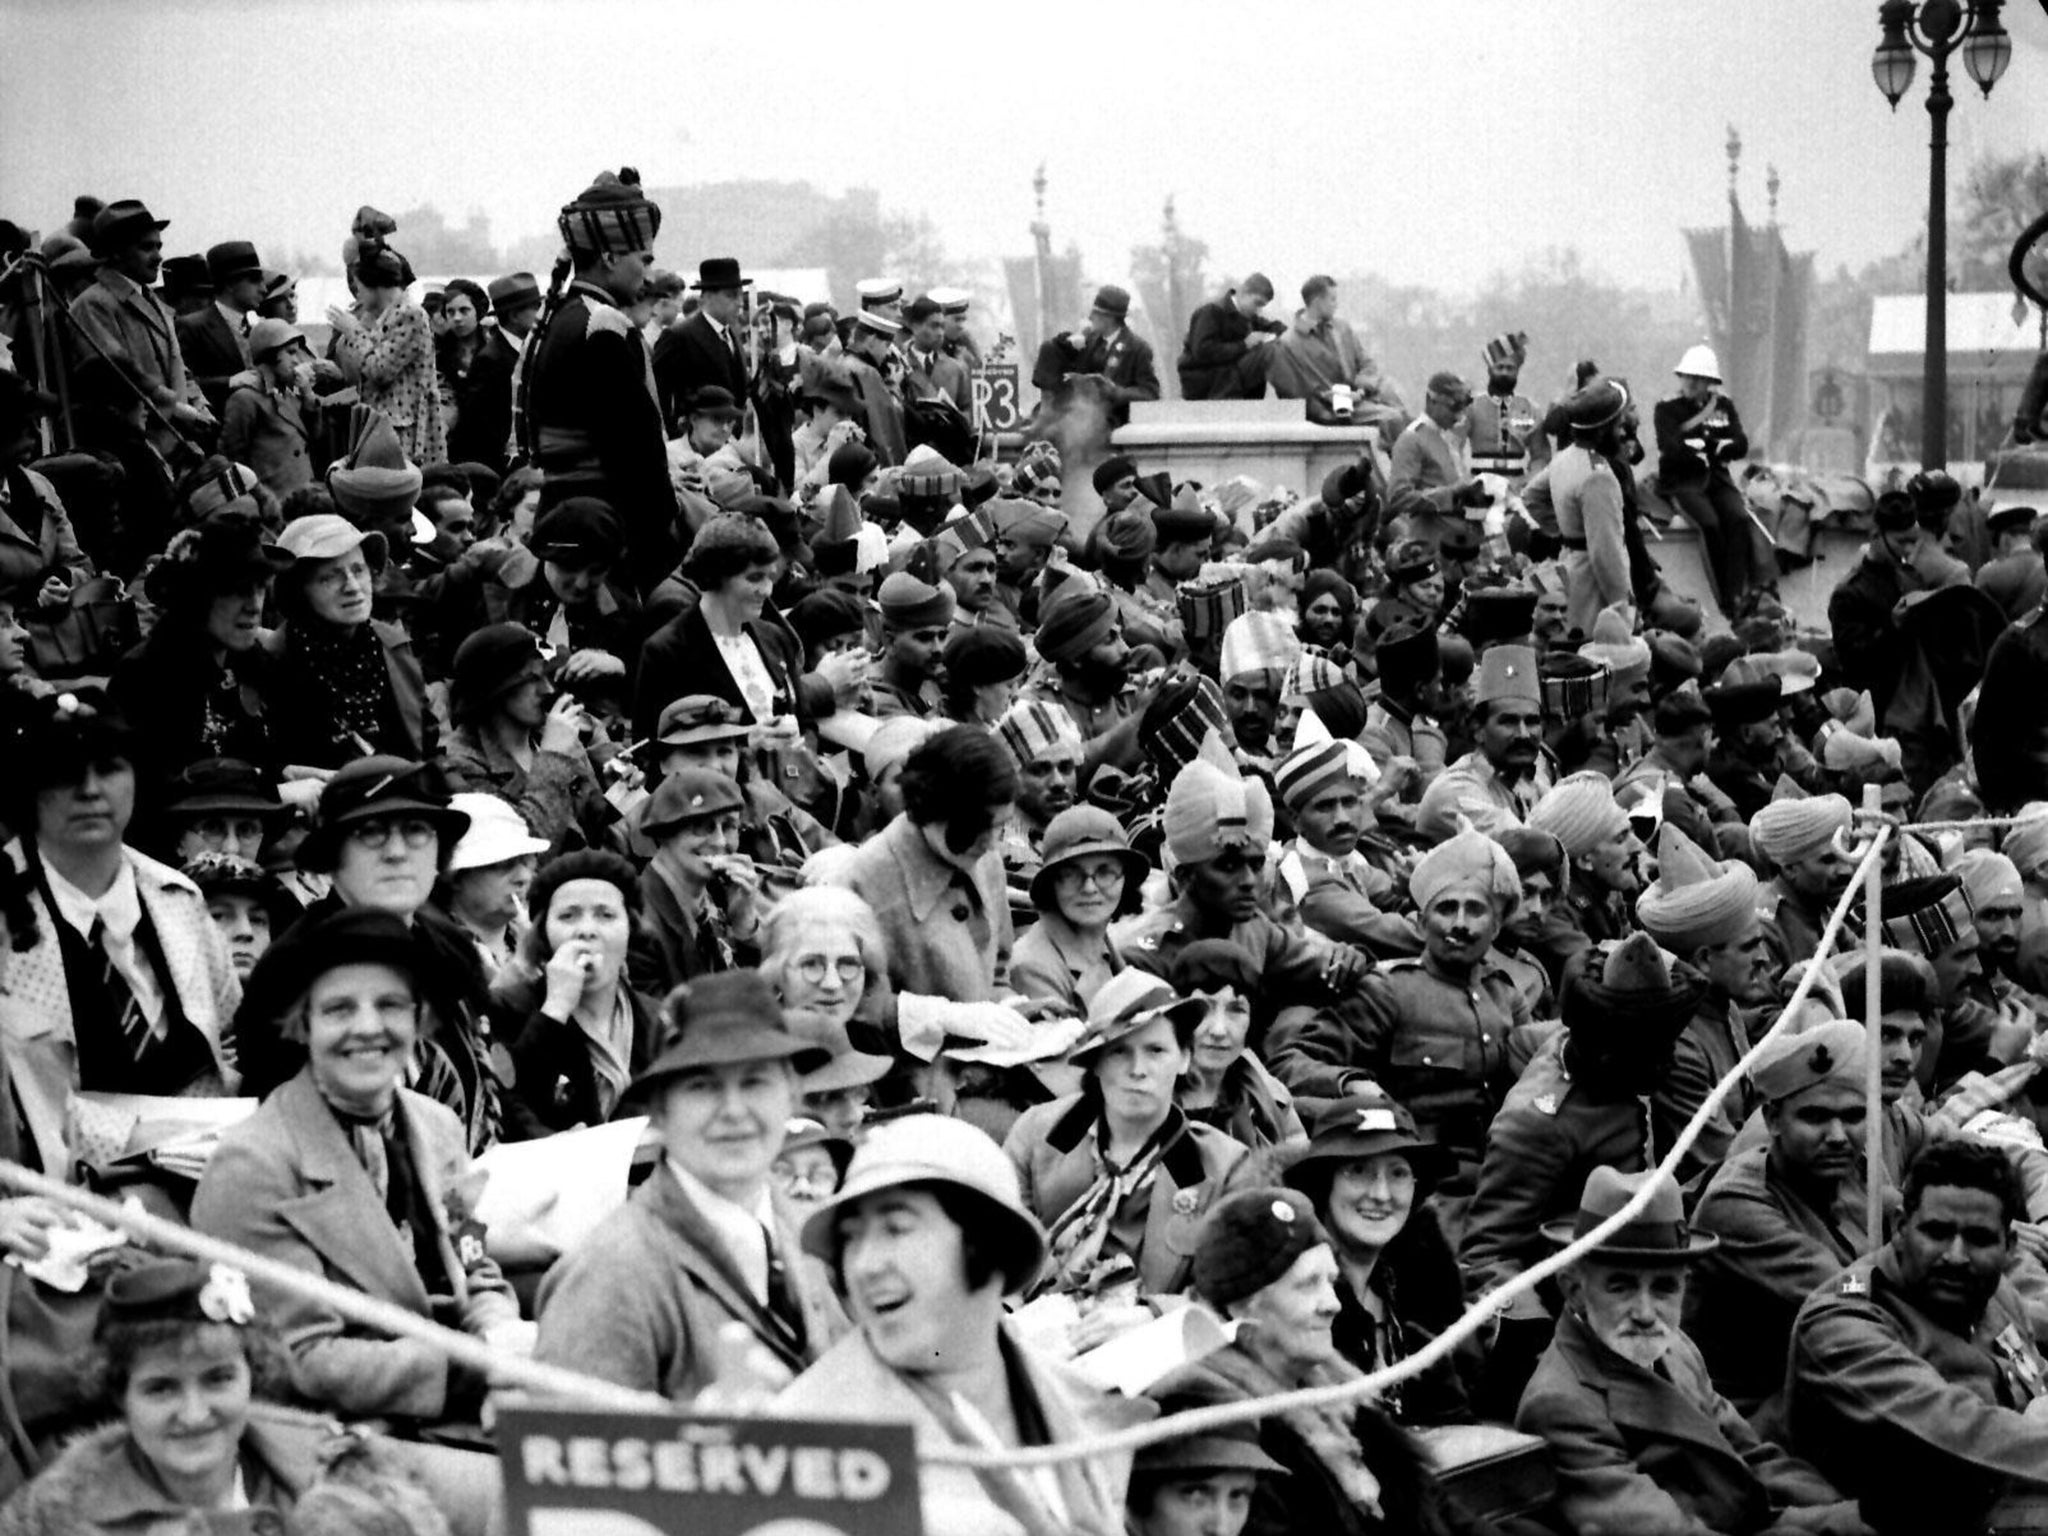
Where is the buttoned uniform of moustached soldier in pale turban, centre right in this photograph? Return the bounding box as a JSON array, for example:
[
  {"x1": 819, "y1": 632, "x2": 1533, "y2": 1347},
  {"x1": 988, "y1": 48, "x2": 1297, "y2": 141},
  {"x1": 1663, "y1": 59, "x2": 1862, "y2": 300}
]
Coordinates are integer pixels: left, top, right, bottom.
[{"x1": 1266, "y1": 954, "x2": 1528, "y2": 1182}]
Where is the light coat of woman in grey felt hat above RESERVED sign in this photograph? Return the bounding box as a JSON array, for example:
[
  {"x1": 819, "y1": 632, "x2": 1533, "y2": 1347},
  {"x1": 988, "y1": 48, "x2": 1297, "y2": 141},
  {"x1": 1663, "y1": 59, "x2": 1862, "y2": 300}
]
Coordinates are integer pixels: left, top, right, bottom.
[{"x1": 535, "y1": 1161, "x2": 852, "y2": 1403}]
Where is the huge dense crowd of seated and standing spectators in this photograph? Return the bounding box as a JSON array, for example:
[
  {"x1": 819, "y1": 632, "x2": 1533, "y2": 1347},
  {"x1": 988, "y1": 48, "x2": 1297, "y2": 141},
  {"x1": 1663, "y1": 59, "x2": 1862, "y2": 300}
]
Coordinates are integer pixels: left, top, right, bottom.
[{"x1": 0, "y1": 172, "x2": 2048, "y2": 1536}]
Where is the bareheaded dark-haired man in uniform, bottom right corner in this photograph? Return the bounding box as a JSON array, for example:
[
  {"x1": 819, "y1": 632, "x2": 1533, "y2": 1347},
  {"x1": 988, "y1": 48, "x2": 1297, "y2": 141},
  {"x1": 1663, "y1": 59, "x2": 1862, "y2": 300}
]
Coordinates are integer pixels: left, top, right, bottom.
[{"x1": 1784, "y1": 1141, "x2": 2048, "y2": 1536}]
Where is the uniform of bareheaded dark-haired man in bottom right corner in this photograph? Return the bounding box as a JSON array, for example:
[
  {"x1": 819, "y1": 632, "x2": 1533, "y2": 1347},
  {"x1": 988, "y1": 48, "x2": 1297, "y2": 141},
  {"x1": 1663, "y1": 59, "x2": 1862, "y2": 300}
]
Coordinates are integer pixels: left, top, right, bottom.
[{"x1": 1786, "y1": 1243, "x2": 2048, "y2": 1536}]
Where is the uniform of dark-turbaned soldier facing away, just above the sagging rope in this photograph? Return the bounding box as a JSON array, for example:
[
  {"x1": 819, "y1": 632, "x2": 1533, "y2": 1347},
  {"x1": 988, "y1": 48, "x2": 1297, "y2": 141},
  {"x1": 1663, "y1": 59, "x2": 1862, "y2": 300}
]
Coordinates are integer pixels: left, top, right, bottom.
[{"x1": 1458, "y1": 1030, "x2": 1657, "y2": 1315}]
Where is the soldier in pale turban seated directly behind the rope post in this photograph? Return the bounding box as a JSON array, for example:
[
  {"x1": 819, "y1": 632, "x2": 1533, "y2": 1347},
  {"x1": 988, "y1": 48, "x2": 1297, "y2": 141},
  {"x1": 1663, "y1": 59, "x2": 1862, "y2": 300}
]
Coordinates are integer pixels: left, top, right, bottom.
[{"x1": 1686, "y1": 1020, "x2": 1870, "y2": 1413}]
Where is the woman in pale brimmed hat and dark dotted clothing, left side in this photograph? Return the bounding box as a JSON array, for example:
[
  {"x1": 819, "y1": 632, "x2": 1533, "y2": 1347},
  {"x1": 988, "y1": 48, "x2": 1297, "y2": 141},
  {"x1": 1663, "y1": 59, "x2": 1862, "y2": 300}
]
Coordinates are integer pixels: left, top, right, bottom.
[{"x1": 264, "y1": 512, "x2": 440, "y2": 776}]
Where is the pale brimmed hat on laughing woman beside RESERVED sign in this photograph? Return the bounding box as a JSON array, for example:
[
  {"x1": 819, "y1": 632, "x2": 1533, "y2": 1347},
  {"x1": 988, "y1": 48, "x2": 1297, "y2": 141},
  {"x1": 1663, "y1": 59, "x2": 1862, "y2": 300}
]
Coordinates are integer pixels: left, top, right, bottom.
[{"x1": 803, "y1": 1114, "x2": 1044, "y2": 1292}]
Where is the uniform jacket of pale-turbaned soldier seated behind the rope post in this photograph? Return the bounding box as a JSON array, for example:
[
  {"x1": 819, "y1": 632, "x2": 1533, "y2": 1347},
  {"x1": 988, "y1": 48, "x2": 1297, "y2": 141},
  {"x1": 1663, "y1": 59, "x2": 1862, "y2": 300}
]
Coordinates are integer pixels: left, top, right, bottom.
[{"x1": 1686, "y1": 1147, "x2": 1868, "y2": 1413}]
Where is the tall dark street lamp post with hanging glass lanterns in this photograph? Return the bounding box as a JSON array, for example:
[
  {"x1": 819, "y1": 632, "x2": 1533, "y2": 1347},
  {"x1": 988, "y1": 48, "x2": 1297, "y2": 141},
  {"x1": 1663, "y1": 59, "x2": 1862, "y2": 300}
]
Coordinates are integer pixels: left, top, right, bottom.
[{"x1": 1870, "y1": 0, "x2": 2007, "y2": 469}]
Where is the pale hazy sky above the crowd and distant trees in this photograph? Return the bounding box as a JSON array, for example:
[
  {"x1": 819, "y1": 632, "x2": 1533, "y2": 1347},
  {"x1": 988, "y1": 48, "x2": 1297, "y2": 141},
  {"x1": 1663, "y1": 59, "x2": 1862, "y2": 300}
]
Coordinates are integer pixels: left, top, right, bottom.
[{"x1": 0, "y1": 0, "x2": 2048, "y2": 293}]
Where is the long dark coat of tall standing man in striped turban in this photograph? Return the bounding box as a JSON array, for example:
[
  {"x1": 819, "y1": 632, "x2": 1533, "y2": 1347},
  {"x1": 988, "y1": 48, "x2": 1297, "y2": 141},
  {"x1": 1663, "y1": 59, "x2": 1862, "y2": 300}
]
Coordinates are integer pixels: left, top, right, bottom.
[{"x1": 524, "y1": 283, "x2": 682, "y2": 590}]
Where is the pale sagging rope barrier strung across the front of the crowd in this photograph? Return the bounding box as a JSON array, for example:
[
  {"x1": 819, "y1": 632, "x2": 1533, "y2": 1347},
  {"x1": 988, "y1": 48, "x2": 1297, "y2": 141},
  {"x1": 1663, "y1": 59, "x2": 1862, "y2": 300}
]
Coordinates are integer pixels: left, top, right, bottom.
[{"x1": 0, "y1": 823, "x2": 1894, "y2": 1468}]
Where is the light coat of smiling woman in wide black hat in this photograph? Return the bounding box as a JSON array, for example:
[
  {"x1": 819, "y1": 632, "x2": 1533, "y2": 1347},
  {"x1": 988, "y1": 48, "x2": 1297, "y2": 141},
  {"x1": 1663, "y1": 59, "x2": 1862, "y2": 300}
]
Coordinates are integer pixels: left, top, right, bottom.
[{"x1": 193, "y1": 1067, "x2": 518, "y2": 1419}]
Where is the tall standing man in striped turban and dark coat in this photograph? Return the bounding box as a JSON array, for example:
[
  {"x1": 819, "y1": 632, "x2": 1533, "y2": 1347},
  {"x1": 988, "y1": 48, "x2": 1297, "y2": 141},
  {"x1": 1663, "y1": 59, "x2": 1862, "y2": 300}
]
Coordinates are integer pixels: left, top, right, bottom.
[{"x1": 518, "y1": 168, "x2": 682, "y2": 594}]
